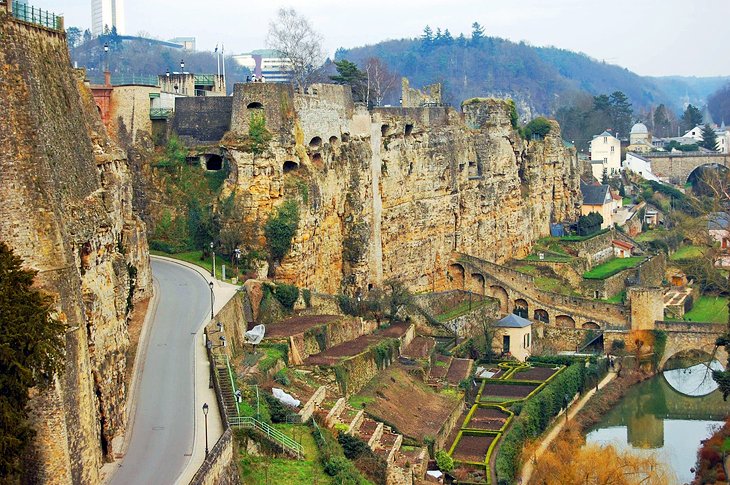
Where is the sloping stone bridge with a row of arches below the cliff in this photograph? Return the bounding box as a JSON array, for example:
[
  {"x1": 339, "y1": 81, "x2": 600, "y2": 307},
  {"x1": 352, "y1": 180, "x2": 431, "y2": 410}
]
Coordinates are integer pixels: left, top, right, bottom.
[{"x1": 449, "y1": 253, "x2": 630, "y2": 330}]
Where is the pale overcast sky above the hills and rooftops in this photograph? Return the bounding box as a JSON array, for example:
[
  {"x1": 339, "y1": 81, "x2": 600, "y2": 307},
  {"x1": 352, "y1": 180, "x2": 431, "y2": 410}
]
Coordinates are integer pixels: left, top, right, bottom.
[{"x1": 48, "y1": 0, "x2": 730, "y2": 76}]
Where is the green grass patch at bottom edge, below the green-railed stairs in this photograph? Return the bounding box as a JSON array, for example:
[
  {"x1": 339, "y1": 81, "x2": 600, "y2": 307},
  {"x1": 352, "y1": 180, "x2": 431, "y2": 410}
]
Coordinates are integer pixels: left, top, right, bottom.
[{"x1": 240, "y1": 424, "x2": 332, "y2": 485}]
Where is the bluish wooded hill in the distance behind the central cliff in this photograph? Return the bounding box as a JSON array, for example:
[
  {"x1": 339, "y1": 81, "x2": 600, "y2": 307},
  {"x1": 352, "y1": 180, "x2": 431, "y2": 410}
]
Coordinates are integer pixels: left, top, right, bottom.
[{"x1": 336, "y1": 37, "x2": 730, "y2": 116}]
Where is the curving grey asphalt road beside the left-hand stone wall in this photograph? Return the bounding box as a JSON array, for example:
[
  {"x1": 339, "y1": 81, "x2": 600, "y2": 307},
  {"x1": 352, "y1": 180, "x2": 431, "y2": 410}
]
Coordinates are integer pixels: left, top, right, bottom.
[{"x1": 110, "y1": 259, "x2": 210, "y2": 485}]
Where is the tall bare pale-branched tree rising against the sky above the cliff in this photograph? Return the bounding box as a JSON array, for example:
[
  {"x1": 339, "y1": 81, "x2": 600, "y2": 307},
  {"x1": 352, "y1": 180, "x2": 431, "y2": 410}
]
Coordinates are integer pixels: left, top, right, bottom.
[{"x1": 266, "y1": 8, "x2": 324, "y2": 88}]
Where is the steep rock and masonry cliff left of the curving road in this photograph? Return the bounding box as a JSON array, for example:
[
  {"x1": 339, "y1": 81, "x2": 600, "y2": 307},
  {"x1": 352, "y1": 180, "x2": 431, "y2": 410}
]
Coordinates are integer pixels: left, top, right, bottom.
[{"x1": 0, "y1": 8, "x2": 152, "y2": 483}]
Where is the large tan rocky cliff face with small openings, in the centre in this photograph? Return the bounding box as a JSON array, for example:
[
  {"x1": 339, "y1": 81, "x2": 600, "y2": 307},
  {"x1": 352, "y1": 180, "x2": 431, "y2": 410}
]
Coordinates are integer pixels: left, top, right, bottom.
[{"x1": 219, "y1": 84, "x2": 580, "y2": 293}]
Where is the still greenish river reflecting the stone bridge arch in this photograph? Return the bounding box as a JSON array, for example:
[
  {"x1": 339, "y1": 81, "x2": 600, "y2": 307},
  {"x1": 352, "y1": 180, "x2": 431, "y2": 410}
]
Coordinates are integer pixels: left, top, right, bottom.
[{"x1": 586, "y1": 362, "x2": 730, "y2": 484}]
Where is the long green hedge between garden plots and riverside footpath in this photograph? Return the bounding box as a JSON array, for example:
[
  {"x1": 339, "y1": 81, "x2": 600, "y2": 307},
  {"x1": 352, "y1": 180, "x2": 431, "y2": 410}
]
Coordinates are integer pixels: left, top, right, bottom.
[{"x1": 496, "y1": 361, "x2": 588, "y2": 483}]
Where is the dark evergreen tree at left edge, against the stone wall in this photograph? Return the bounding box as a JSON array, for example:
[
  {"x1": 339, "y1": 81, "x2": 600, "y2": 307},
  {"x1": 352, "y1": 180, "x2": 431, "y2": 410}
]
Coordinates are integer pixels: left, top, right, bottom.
[{"x1": 0, "y1": 242, "x2": 66, "y2": 483}]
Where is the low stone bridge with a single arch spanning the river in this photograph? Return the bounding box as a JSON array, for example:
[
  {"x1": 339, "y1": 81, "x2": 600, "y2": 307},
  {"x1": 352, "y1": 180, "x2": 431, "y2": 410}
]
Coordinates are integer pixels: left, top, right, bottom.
[{"x1": 655, "y1": 322, "x2": 727, "y2": 369}]
